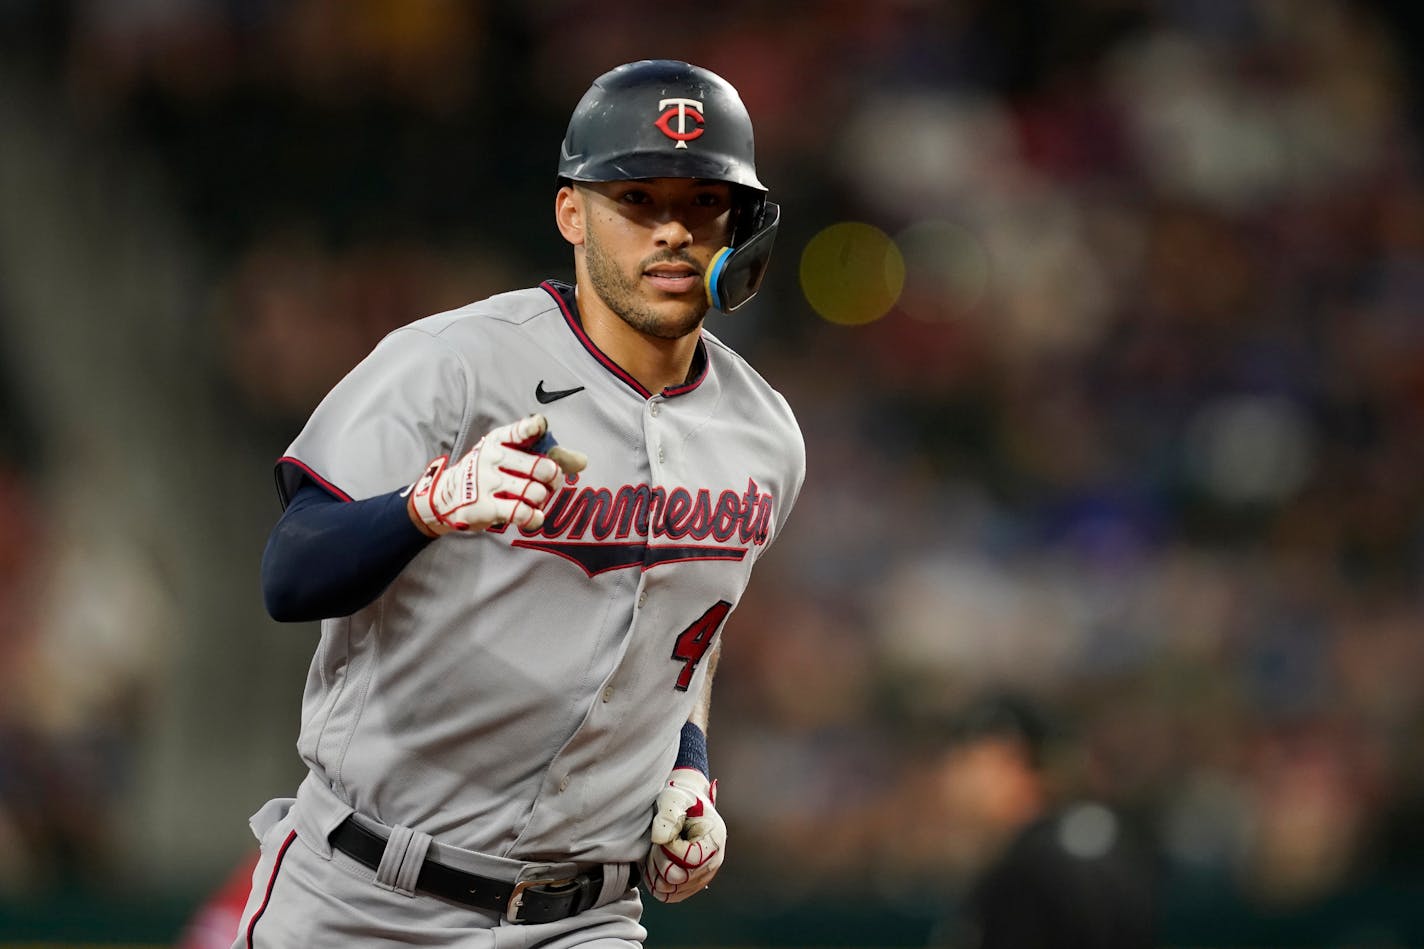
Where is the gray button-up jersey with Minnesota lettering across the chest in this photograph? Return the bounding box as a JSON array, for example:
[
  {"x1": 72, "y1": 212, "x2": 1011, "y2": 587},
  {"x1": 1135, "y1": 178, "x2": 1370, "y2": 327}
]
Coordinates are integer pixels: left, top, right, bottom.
[{"x1": 279, "y1": 277, "x2": 806, "y2": 862}]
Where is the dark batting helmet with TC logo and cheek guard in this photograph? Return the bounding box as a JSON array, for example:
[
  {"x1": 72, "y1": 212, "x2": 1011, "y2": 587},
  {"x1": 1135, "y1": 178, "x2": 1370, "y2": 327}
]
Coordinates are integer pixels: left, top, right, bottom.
[{"x1": 558, "y1": 60, "x2": 780, "y2": 312}]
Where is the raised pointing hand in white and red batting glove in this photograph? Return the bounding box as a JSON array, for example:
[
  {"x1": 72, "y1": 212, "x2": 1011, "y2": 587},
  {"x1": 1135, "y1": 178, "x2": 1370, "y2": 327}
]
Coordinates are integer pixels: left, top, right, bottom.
[{"x1": 406, "y1": 415, "x2": 588, "y2": 537}]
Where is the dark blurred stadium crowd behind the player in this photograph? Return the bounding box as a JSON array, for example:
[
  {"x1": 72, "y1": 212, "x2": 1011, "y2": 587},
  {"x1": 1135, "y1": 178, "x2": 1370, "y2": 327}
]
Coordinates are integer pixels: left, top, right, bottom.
[{"x1": 0, "y1": 0, "x2": 1424, "y2": 946}]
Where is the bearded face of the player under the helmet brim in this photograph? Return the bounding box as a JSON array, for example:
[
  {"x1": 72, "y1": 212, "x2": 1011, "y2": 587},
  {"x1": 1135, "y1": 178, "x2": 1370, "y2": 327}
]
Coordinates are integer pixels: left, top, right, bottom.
[{"x1": 566, "y1": 178, "x2": 732, "y2": 339}]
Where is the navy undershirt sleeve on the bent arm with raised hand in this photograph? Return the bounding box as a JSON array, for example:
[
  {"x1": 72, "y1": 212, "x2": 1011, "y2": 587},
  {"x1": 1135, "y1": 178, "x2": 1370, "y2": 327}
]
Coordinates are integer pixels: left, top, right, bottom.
[{"x1": 262, "y1": 480, "x2": 431, "y2": 623}]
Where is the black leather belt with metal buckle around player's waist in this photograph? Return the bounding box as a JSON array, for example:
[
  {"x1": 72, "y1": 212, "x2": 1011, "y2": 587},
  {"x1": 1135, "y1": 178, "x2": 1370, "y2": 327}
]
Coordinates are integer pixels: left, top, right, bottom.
[{"x1": 329, "y1": 818, "x2": 638, "y2": 923}]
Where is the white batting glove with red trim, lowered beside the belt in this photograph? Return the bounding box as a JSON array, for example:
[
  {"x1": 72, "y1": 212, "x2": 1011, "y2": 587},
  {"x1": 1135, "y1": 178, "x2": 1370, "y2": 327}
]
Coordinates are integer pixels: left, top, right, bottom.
[{"x1": 644, "y1": 768, "x2": 726, "y2": 903}]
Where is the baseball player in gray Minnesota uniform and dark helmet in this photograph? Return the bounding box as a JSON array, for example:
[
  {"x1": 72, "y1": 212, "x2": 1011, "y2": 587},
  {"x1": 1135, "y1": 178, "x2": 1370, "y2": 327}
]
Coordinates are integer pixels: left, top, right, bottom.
[{"x1": 234, "y1": 61, "x2": 805, "y2": 948}]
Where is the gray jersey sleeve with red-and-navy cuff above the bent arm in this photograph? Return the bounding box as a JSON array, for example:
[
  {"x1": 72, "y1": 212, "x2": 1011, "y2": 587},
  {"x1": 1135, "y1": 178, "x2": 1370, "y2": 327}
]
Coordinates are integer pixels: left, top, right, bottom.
[{"x1": 278, "y1": 326, "x2": 474, "y2": 503}]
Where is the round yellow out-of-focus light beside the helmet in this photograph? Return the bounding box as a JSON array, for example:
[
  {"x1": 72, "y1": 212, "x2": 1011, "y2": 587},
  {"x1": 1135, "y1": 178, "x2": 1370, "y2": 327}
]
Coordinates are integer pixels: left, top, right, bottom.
[{"x1": 800, "y1": 221, "x2": 904, "y2": 326}]
